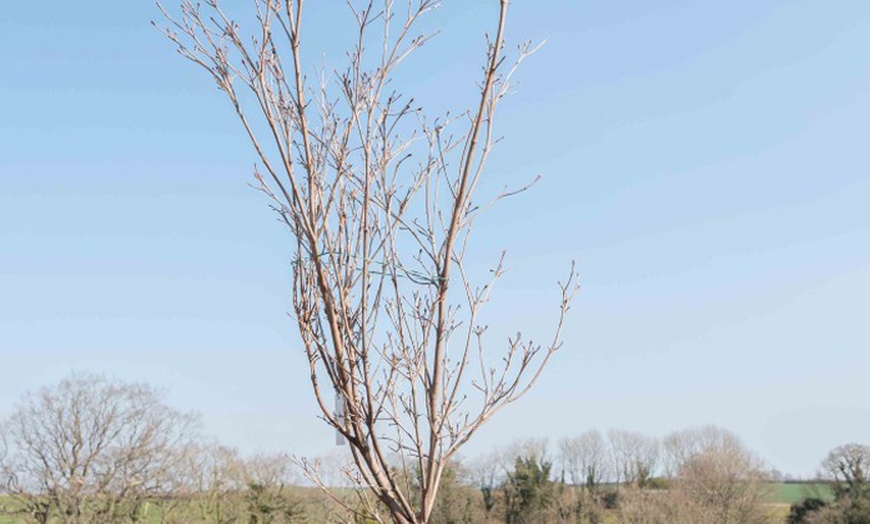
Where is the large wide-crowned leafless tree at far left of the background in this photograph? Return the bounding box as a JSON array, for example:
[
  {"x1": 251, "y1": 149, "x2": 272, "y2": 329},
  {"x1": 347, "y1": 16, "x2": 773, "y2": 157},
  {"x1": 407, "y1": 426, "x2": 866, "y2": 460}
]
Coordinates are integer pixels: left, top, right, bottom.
[{"x1": 2, "y1": 375, "x2": 195, "y2": 523}]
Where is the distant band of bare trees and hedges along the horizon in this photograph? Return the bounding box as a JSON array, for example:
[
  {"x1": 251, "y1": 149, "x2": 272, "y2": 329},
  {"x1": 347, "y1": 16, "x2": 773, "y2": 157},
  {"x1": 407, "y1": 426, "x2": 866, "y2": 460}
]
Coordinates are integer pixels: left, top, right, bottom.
[{"x1": 0, "y1": 374, "x2": 870, "y2": 524}]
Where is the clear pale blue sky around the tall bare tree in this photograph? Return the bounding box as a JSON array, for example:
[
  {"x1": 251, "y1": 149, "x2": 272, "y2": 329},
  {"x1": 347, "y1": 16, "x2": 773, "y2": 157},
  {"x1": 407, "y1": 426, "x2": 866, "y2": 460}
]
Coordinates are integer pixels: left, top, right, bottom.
[{"x1": 0, "y1": 0, "x2": 870, "y2": 475}]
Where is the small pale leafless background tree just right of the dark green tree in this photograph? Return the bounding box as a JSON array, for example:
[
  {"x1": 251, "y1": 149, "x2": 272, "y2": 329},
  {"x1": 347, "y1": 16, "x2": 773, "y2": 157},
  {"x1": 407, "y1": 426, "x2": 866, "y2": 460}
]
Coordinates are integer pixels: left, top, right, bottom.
[{"x1": 559, "y1": 429, "x2": 611, "y2": 489}]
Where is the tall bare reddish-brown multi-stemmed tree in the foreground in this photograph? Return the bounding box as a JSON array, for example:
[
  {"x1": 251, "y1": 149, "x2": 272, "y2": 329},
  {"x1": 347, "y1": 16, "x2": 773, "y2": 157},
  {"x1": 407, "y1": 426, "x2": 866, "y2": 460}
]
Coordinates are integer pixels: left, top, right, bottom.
[{"x1": 161, "y1": 0, "x2": 576, "y2": 523}]
